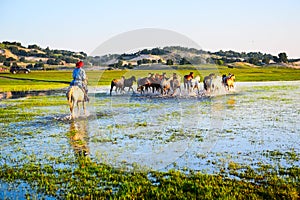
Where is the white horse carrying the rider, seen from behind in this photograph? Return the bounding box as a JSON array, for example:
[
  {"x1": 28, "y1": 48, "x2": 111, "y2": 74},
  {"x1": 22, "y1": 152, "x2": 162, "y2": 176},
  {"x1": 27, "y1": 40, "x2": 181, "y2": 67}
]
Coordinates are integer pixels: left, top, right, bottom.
[{"x1": 67, "y1": 86, "x2": 86, "y2": 119}]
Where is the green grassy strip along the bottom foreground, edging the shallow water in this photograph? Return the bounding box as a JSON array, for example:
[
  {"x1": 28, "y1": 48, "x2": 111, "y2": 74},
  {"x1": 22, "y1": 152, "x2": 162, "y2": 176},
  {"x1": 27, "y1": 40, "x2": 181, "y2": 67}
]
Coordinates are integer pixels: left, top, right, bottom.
[{"x1": 0, "y1": 157, "x2": 300, "y2": 199}]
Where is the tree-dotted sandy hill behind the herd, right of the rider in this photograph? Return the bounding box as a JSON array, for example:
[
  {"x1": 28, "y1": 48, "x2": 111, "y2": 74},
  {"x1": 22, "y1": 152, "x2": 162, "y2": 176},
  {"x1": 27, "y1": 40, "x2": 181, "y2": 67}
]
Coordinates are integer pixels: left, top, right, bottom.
[{"x1": 87, "y1": 46, "x2": 299, "y2": 69}]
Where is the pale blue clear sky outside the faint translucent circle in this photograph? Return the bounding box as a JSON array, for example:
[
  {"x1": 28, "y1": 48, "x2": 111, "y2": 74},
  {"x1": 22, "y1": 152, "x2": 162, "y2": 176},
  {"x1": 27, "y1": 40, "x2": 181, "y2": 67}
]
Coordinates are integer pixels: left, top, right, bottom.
[{"x1": 0, "y1": 0, "x2": 300, "y2": 58}]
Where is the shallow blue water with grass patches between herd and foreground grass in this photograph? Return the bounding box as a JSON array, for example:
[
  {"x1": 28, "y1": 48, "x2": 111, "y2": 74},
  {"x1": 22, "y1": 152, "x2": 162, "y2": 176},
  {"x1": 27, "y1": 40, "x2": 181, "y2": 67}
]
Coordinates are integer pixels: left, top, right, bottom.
[{"x1": 0, "y1": 82, "x2": 300, "y2": 173}]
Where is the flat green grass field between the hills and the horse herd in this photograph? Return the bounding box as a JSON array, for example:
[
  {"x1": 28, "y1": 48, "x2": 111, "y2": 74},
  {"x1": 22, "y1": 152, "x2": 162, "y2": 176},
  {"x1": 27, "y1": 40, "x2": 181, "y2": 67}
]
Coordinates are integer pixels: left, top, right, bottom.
[{"x1": 0, "y1": 65, "x2": 300, "y2": 92}]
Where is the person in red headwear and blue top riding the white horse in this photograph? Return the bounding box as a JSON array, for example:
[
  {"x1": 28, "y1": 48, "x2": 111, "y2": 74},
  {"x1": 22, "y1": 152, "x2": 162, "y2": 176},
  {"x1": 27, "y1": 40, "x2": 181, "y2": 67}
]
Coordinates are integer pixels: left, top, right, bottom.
[{"x1": 70, "y1": 61, "x2": 89, "y2": 101}]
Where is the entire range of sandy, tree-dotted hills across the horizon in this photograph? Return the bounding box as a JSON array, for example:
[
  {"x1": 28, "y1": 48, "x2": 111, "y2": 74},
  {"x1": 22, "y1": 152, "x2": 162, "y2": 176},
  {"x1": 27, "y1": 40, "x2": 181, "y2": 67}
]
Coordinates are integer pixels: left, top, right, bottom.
[{"x1": 0, "y1": 41, "x2": 300, "y2": 70}]
